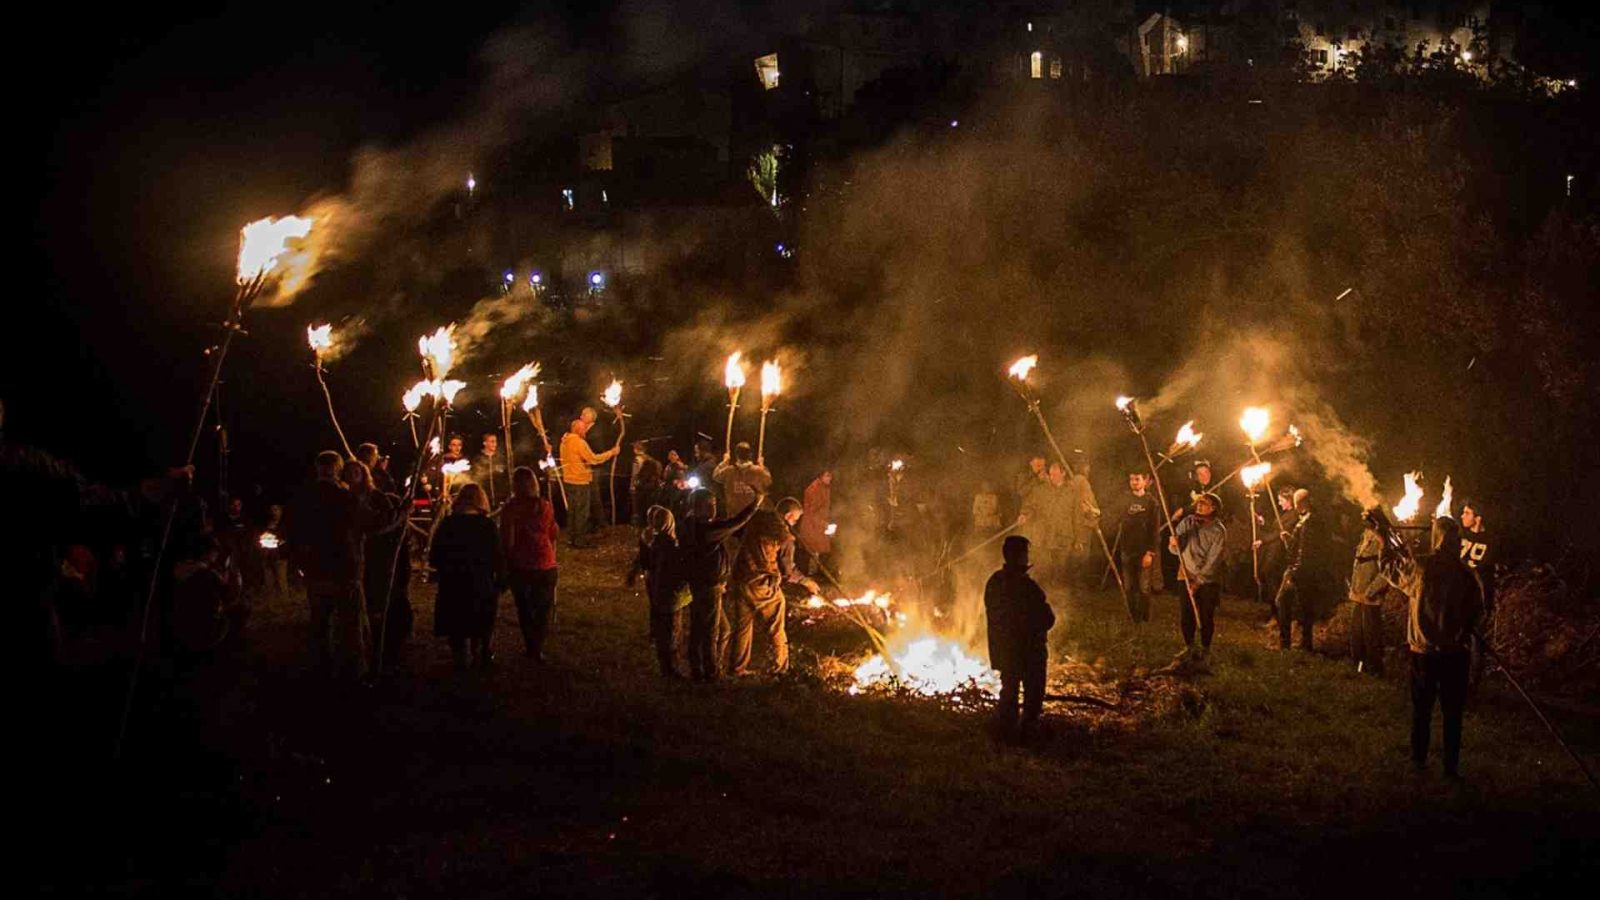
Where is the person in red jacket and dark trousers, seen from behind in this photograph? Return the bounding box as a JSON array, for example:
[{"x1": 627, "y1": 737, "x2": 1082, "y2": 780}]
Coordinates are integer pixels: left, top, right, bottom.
[{"x1": 501, "y1": 466, "x2": 560, "y2": 663}]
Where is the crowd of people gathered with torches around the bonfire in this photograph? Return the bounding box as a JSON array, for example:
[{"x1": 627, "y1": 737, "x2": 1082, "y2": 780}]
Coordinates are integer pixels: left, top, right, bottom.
[{"x1": 6, "y1": 389, "x2": 1496, "y2": 772}]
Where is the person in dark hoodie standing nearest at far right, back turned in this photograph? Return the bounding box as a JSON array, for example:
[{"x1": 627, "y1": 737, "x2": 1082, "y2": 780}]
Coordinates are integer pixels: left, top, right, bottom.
[{"x1": 1384, "y1": 516, "x2": 1483, "y2": 778}]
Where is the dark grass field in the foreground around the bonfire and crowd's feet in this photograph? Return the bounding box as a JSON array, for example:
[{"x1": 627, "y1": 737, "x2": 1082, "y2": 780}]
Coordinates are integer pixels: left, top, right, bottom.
[{"x1": 46, "y1": 525, "x2": 1600, "y2": 898}]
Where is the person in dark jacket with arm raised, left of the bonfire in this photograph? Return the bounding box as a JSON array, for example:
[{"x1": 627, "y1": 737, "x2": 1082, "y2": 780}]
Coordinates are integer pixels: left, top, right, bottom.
[{"x1": 678, "y1": 488, "x2": 763, "y2": 681}]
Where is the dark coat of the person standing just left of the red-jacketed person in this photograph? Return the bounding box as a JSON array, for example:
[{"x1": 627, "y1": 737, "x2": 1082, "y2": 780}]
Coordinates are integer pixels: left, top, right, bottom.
[{"x1": 427, "y1": 512, "x2": 504, "y2": 637}]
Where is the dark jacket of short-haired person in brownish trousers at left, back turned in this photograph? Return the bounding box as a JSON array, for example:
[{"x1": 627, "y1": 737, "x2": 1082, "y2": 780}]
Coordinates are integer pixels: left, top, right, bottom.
[{"x1": 285, "y1": 479, "x2": 389, "y2": 581}]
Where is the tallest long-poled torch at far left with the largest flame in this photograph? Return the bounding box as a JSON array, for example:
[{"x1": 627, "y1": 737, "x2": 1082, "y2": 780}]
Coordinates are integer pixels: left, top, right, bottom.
[{"x1": 112, "y1": 216, "x2": 314, "y2": 759}]
